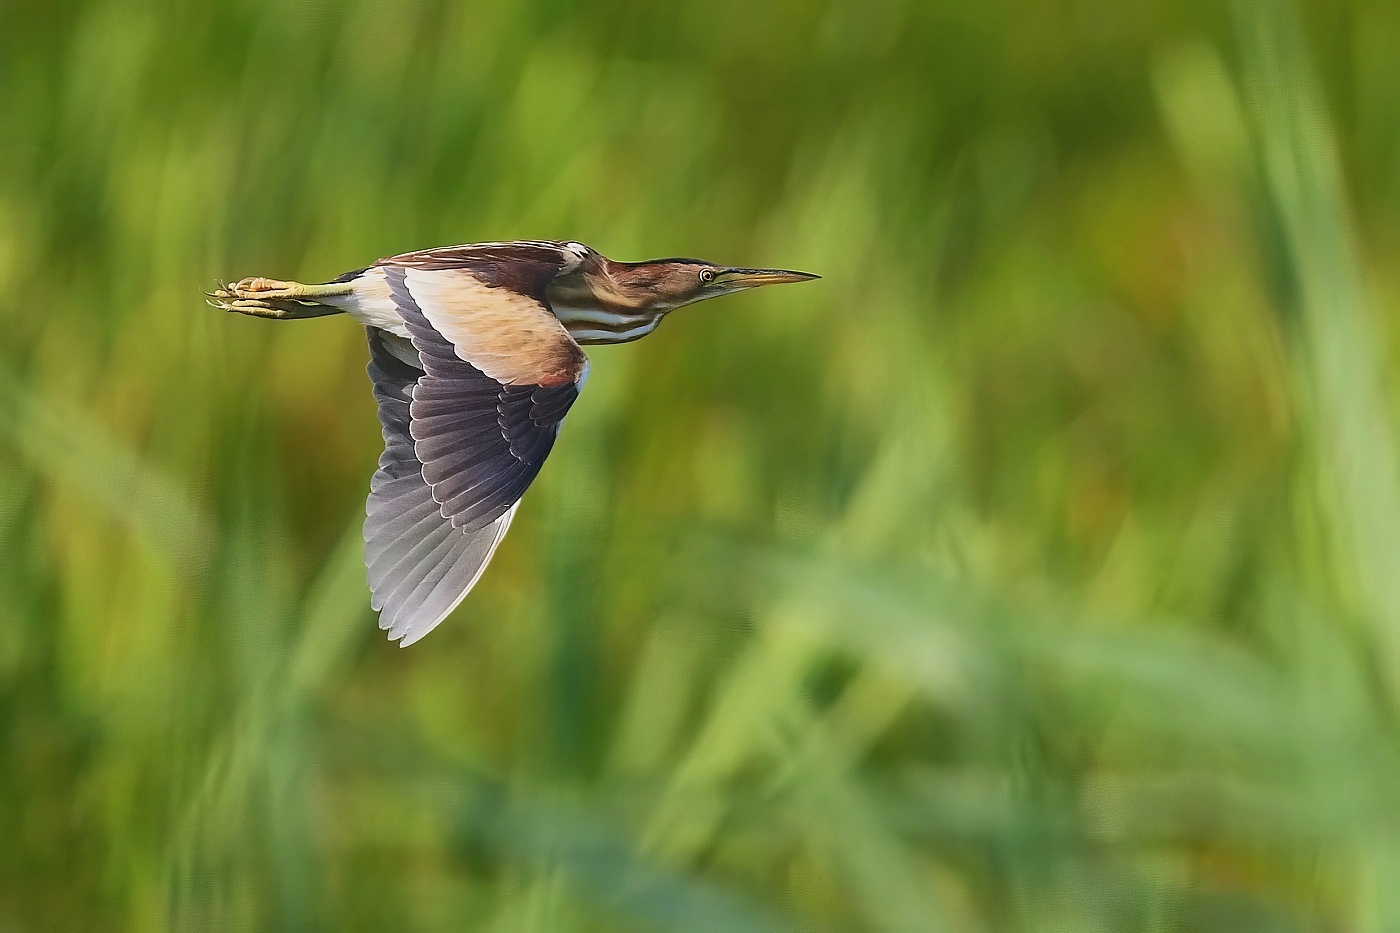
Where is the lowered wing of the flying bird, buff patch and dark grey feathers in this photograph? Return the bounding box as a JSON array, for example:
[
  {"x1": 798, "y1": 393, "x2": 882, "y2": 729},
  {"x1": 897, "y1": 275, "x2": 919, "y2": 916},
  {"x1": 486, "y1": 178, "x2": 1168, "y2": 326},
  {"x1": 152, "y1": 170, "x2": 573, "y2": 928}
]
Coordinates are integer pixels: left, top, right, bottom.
[{"x1": 365, "y1": 254, "x2": 588, "y2": 644}]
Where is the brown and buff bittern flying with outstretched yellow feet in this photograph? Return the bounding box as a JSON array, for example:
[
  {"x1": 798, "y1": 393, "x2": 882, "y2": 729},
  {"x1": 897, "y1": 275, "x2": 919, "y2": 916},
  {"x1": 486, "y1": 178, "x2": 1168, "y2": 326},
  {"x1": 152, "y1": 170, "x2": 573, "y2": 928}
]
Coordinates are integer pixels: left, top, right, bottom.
[{"x1": 206, "y1": 240, "x2": 820, "y2": 647}]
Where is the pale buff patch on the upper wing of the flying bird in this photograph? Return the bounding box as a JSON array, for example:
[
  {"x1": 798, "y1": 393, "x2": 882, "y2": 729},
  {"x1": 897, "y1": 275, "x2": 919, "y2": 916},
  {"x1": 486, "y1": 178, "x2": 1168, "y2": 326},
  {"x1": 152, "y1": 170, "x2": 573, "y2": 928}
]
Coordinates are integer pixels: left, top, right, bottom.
[{"x1": 403, "y1": 268, "x2": 582, "y2": 385}]
